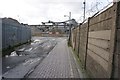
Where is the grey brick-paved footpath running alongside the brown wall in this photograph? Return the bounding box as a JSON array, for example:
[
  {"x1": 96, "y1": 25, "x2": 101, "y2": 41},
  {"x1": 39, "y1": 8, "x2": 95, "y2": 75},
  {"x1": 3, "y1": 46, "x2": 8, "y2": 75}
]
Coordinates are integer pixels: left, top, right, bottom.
[{"x1": 28, "y1": 39, "x2": 82, "y2": 78}]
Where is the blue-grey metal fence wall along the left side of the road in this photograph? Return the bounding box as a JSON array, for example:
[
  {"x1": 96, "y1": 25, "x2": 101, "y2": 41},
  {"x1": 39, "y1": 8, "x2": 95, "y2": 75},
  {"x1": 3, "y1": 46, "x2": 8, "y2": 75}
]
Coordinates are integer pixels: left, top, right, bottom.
[{"x1": 2, "y1": 18, "x2": 31, "y2": 49}]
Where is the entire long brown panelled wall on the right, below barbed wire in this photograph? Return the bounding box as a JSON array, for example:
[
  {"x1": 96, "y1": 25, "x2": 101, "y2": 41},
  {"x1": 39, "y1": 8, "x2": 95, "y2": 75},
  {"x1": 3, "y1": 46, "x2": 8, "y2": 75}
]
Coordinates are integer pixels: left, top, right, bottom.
[{"x1": 72, "y1": 3, "x2": 120, "y2": 78}]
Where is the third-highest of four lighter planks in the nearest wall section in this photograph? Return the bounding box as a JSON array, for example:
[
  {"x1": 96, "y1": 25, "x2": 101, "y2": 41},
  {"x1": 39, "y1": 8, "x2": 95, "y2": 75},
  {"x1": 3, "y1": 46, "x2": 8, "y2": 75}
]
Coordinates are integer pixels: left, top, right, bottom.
[{"x1": 88, "y1": 44, "x2": 110, "y2": 61}]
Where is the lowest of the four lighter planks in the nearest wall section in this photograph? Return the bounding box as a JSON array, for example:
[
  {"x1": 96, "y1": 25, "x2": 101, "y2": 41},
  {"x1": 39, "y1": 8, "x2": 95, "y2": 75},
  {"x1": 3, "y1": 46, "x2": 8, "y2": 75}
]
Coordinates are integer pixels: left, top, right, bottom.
[{"x1": 87, "y1": 50, "x2": 108, "y2": 71}]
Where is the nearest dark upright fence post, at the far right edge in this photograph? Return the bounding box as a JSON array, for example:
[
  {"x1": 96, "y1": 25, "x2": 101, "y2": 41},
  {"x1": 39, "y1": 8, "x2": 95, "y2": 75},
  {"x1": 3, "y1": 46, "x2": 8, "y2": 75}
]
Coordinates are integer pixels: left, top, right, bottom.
[{"x1": 111, "y1": 2, "x2": 120, "y2": 78}]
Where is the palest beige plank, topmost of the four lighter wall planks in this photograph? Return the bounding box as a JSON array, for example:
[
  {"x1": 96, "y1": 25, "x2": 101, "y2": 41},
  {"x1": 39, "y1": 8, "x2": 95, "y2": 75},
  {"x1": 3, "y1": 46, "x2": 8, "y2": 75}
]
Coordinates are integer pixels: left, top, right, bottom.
[{"x1": 89, "y1": 30, "x2": 111, "y2": 40}]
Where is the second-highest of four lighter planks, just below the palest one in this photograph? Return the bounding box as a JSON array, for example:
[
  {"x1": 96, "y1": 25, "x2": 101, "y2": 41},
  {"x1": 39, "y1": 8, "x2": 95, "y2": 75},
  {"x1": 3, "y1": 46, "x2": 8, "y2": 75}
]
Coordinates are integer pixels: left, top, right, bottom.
[{"x1": 88, "y1": 38, "x2": 110, "y2": 49}]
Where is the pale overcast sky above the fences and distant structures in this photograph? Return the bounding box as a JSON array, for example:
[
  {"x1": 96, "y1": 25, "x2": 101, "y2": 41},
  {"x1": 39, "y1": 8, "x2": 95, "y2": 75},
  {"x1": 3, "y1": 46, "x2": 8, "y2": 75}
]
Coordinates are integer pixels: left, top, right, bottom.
[{"x1": 0, "y1": 0, "x2": 112, "y2": 24}]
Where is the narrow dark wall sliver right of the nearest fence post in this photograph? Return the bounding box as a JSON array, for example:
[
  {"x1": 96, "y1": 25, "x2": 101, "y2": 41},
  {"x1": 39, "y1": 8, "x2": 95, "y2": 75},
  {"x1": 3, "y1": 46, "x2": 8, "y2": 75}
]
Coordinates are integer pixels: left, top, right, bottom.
[{"x1": 113, "y1": 2, "x2": 120, "y2": 78}]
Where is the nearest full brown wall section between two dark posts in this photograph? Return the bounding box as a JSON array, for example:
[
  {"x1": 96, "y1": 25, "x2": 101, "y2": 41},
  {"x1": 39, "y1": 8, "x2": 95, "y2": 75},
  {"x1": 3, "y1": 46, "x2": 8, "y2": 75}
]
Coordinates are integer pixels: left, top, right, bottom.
[{"x1": 86, "y1": 6, "x2": 115, "y2": 78}]
